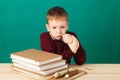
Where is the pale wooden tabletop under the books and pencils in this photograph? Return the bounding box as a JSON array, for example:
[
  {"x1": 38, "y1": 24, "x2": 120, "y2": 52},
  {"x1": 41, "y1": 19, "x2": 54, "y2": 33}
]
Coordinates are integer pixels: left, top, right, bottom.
[{"x1": 0, "y1": 63, "x2": 120, "y2": 80}]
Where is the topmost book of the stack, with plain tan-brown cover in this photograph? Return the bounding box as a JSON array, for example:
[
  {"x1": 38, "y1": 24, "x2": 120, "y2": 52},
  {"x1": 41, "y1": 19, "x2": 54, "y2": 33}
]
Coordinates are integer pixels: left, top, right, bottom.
[{"x1": 10, "y1": 49, "x2": 62, "y2": 66}]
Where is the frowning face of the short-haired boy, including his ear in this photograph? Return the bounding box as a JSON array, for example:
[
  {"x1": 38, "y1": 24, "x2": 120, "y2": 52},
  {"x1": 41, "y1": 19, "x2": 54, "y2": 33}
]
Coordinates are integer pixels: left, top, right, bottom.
[{"x1": 46, "y1": 19, "x2": 68, "y2": 40}]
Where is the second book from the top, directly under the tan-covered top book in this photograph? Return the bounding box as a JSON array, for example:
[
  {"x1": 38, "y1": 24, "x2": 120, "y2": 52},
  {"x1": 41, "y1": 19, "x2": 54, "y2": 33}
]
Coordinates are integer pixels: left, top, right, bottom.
[{"x1": 12, "y1": 59, "x2": 66, "y2": 71}]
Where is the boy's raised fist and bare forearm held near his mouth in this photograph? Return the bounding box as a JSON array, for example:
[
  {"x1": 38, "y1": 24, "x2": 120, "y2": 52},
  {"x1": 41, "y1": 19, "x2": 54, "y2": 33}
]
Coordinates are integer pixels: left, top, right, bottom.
[{"x1": 63, "y1": 34, "x2": 79, "y2": 53}]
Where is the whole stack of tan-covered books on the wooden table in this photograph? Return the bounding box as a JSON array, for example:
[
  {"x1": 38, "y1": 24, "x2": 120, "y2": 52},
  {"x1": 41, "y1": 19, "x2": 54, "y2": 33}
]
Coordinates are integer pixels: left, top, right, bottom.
[{"x1": 10, "y1": 49, "x2": 68, "y2": 79}]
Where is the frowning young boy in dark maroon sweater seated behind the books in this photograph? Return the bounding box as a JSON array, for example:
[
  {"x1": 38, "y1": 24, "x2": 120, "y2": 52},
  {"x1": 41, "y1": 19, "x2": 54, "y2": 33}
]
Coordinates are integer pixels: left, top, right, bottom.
[{"x1": 40, "y1": 6, "x2": 86, "y2": 65}]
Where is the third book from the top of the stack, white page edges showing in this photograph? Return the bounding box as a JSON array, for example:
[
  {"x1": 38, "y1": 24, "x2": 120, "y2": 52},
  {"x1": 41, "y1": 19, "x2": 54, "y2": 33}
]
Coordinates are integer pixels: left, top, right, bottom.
[{"x1": 13, "y1": 63, "x2": 68, "y2": 75}]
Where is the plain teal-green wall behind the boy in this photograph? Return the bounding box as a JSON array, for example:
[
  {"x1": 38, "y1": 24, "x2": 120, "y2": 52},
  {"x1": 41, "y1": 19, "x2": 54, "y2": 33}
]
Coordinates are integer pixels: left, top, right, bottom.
[{"x1": 0, "y1": 0, "x2": 120, "y2": 63}]
